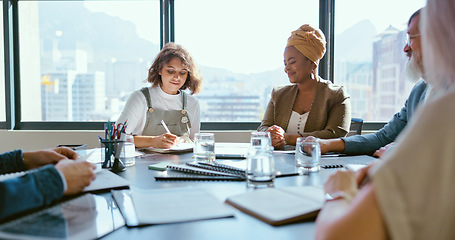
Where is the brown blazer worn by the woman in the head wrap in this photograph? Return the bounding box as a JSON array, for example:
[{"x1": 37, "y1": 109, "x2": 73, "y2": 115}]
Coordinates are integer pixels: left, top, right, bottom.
[{"x1": 258, "y1": 79, "x2": 351, "y2": 138}]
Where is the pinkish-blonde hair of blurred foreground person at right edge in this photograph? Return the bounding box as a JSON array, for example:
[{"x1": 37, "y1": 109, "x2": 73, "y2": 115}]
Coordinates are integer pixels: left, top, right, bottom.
[{"x1": 421, "y1": 0, "x2": 455, "y2": 90}]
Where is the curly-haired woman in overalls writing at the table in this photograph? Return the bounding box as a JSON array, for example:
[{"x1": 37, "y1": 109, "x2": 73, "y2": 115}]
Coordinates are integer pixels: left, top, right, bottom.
[{"x1": 117, "y1": 43, "x2": 202, "y2": 148}]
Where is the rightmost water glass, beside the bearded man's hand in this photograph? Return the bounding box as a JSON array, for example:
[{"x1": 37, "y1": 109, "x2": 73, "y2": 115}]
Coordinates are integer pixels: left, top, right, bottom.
[{"x1": 295, "y1": 137, "x2": 321, "y2": 174}]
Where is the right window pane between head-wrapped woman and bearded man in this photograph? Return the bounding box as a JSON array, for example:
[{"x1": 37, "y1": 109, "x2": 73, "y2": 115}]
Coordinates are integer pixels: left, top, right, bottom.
[{"x1": 334, "y1": 0, "x2": 425, "y2": 121}]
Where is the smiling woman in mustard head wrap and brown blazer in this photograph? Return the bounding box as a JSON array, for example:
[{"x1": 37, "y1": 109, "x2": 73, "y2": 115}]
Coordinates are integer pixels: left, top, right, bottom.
[{"x1": 258, "y1": 24, "x2": 351, "y2": 148}]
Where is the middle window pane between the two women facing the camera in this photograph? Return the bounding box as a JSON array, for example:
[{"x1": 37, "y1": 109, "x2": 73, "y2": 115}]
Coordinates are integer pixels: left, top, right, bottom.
[{"x1": 175, "y1": 0, "x2": 319, "y2": 122}]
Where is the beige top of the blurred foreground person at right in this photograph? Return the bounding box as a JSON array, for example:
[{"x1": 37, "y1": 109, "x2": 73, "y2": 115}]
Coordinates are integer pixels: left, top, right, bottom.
[{"x1": 369, "y1": 88, "x2": 455, "y2": 240}]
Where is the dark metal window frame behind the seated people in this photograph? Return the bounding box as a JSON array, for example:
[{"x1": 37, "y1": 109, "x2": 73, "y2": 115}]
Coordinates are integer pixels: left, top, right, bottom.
[{"x1": 0, "y1": 0, "x2": 384, "y2": 130}]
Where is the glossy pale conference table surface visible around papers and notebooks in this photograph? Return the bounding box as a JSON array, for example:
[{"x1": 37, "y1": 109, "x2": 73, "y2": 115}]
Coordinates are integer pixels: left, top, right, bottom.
[{"x1": 103, "y1": 146, "x2": 373, "y2": 240}]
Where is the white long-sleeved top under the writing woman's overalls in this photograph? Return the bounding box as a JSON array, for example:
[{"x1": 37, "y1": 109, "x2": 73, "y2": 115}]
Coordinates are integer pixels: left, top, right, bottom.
[{"x1": 117, "y1": 87, "x2": 201, "y2": 138}]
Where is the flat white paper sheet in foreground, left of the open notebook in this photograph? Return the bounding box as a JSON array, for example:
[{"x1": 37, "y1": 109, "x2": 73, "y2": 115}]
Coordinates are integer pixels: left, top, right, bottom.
[{"x1": 131, "y1": 188, "x2": 234, "y2": 224}]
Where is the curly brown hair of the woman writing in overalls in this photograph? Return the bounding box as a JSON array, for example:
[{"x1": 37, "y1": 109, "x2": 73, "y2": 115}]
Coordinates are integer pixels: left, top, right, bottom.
[{"x1": 147, "y1": 42, "x2": 202, "y2": 94}]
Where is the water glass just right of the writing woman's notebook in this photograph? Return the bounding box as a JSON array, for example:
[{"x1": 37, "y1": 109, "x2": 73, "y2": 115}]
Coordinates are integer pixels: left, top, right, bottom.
[{"x1": 193, "y1": 133, "x2": 215, "y2": 162}]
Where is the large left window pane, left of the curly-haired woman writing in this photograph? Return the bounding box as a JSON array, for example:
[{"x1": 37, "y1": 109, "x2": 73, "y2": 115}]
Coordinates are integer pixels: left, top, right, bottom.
[{"x1": 18, "y1": 0, "x2": 160, "y2": 122}]
